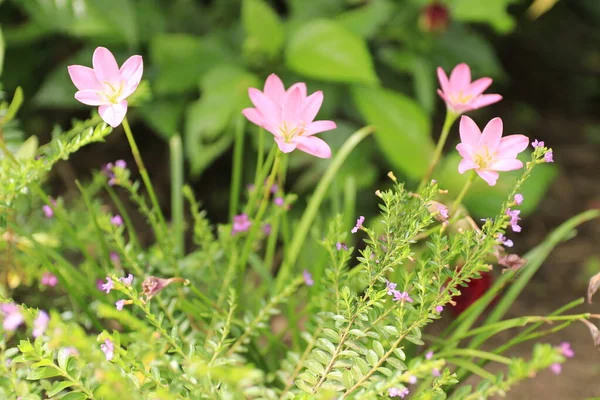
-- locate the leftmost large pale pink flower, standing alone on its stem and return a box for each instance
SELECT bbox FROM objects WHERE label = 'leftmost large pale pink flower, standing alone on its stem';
[68,47,144,128]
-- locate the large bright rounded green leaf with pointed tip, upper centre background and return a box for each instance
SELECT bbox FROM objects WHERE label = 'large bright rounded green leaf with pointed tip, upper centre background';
[285,20,378,84]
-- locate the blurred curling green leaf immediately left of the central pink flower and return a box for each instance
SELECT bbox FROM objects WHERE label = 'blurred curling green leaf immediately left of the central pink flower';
[184,65,258,174]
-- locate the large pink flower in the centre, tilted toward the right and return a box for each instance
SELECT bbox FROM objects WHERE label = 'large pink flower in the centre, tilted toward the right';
[242,74,336,158]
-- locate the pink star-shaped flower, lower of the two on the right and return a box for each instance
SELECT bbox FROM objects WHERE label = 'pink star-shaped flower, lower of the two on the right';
[456,116,529,186]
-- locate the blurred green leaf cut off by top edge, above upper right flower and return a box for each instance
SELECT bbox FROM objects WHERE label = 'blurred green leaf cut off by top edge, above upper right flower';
[450,0,516,33]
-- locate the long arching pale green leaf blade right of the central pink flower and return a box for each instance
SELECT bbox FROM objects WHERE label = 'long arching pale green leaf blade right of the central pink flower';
[275,126,374,292]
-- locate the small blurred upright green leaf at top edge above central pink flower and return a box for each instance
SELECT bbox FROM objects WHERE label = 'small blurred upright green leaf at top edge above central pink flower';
[242,0,285,58]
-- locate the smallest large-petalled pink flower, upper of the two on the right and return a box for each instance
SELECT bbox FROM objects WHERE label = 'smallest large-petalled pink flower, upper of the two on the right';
[438,63,502,114]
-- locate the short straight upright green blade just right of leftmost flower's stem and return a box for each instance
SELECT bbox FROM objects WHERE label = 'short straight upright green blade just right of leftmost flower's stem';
[169,134,185,260]
